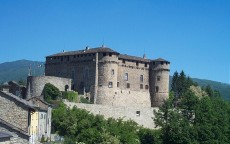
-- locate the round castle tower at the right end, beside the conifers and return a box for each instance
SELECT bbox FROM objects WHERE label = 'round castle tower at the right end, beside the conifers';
[149,58,170,107]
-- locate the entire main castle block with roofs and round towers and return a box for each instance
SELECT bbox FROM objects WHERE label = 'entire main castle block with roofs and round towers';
[45,46,170,107]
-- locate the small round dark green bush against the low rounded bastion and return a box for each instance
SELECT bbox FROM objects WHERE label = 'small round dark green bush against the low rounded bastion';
[43,83,61,102]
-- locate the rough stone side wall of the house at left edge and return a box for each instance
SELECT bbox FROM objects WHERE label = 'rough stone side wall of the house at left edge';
[0,93,29,132]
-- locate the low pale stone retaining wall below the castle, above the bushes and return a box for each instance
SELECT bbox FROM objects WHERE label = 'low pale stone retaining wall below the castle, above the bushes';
[65,102,158,129]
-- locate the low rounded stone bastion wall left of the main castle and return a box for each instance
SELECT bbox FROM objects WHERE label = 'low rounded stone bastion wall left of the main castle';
[26,76,71,99]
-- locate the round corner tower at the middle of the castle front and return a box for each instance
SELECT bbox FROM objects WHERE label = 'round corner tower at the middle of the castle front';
[95,52,119,105]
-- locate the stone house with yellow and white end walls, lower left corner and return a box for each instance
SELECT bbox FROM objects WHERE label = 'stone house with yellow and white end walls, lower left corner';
[0,91,51,144]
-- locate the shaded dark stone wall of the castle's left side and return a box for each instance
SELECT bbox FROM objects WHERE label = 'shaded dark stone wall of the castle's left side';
[45,54,96,94]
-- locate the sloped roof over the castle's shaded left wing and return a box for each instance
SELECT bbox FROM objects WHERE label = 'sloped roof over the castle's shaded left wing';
[47,47,119,57]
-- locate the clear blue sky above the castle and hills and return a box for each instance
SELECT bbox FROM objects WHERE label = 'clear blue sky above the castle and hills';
[0,0,230,83]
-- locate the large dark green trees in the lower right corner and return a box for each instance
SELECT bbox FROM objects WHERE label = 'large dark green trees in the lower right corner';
[154,90,230,144]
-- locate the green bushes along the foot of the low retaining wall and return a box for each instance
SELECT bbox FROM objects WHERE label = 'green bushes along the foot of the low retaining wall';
[52,104,155,144]
